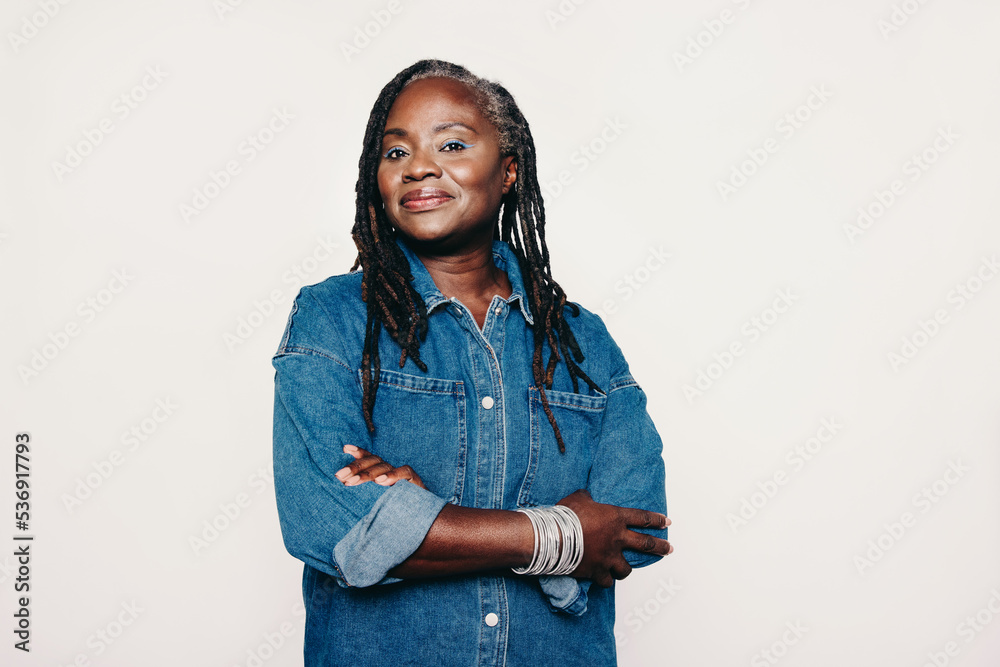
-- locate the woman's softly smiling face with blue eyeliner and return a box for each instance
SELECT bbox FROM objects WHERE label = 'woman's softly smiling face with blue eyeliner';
[378,78,517,253]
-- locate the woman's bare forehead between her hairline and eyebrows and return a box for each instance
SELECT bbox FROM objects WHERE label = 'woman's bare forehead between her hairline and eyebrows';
[386,77,491,131]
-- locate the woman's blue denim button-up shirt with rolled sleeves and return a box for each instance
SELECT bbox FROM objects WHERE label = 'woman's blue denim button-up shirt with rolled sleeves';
[272,240,667,667]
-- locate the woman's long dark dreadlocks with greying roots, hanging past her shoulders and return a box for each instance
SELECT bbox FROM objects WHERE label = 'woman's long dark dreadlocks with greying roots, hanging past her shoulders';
[351,60,601,452]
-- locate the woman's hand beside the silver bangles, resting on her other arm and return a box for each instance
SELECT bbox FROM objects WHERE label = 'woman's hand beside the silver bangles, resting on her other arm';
[557,489,674,588]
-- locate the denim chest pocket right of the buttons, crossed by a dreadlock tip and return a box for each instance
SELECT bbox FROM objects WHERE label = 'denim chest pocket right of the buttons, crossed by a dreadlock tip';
[517,387,608,507]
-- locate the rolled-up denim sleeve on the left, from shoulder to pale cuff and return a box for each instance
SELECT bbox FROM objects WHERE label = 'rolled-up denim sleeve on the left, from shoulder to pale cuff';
[272,290,445,587]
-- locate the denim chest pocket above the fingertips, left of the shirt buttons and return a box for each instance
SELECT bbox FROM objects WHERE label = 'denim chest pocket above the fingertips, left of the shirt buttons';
[358,370,467,503]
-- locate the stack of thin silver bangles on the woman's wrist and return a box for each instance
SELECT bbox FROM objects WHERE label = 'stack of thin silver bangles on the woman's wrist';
[511,505,583,575]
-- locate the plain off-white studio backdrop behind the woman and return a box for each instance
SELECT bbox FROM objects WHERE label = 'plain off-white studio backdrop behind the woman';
[0,0,1000,667]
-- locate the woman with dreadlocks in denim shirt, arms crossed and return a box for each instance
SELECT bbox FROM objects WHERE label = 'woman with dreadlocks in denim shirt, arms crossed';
[273,61,671,665]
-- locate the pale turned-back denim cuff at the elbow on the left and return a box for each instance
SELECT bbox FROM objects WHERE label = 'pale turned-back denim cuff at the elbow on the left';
[333,481,446,587]
